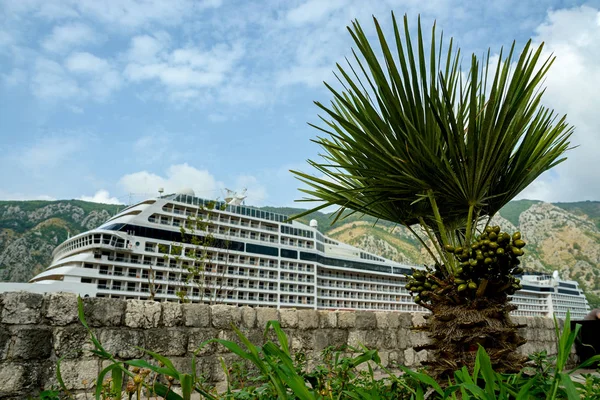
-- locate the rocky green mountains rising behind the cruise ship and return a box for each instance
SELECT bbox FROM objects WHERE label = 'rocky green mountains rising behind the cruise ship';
[0,200,600,306]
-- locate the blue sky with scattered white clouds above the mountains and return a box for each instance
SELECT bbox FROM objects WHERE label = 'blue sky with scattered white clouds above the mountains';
[0,0,600,206]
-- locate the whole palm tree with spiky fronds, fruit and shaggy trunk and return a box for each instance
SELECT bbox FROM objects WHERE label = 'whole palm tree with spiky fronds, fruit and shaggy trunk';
[292,14,573,378]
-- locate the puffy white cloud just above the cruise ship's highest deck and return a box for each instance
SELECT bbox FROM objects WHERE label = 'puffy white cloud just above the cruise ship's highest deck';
[119,163,220,198]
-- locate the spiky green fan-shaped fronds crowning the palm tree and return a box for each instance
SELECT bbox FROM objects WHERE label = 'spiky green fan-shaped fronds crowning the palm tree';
[292,14,573,270]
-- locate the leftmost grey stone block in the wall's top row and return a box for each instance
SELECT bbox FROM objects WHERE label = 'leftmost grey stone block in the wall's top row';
[0,292,44,324]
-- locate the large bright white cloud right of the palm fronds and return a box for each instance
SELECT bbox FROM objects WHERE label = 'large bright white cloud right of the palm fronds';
[520,6,600,201]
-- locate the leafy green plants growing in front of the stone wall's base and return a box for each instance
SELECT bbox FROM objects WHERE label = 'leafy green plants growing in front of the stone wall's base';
[49,299,600,400]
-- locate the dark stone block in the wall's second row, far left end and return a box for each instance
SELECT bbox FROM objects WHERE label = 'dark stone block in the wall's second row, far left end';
[8,327,52,360]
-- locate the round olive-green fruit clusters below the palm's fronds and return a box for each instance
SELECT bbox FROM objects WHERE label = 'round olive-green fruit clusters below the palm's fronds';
[406,226,525,303]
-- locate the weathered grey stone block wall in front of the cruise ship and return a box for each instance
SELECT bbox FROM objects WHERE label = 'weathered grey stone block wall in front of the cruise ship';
[0,292,568,399]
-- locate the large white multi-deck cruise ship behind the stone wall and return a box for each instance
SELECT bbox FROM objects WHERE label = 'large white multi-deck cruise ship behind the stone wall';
[0,189,589,319]
